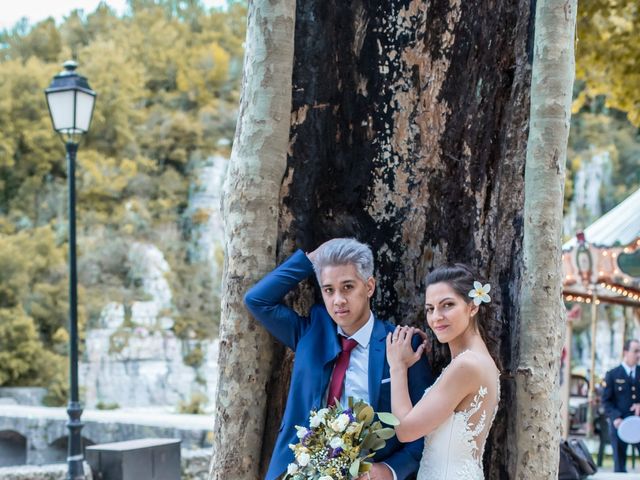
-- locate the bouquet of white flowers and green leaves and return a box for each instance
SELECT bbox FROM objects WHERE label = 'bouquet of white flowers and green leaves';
[284,398,399,480]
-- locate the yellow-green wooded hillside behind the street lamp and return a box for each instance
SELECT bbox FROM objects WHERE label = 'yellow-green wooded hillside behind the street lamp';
[0,0,246,394]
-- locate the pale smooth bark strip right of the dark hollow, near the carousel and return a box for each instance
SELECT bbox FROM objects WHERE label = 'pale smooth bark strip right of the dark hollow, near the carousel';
[515,0,577,479]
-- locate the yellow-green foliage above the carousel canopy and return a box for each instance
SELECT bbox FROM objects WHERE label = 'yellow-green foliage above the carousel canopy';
[564,0,640,228]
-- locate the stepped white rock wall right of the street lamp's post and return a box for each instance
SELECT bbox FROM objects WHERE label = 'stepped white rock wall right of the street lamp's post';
[80,242,218,409]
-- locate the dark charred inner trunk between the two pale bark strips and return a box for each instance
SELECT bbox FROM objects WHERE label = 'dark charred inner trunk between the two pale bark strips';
[265,0,533,478]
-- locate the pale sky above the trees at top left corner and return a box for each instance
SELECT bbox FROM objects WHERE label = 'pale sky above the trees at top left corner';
[0,0,226,30]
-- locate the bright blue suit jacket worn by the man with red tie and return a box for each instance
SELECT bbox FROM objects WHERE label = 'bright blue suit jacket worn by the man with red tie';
[245,251,433,480]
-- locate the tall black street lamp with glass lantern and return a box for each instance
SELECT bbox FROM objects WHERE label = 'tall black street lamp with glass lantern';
[44,60,96,480]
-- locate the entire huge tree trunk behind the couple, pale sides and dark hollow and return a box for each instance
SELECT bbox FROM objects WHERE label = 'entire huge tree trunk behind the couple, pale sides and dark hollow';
[212,0,575,479]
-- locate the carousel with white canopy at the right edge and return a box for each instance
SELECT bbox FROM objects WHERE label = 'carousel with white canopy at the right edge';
[562,190,640,435]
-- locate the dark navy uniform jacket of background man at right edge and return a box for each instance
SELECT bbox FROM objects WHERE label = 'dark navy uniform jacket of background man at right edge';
[602,365,640,421]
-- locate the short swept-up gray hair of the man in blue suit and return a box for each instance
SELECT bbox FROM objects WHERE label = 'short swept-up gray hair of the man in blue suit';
[313,238,373,283]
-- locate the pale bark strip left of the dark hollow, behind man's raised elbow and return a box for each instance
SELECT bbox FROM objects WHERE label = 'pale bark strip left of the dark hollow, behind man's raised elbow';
[209,0,295,480]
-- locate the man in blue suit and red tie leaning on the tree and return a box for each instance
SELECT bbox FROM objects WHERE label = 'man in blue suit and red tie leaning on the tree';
[245,238,433,480]
